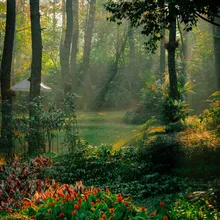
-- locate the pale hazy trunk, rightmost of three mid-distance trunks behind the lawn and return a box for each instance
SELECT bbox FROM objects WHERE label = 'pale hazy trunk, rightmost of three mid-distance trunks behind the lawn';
[82,0,96,109]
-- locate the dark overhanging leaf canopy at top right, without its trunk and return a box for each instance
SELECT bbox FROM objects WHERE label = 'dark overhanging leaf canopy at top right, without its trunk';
[105,0,220,51]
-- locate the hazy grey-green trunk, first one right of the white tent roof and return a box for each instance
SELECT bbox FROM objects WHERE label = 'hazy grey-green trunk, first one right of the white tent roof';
[61,0,73,95]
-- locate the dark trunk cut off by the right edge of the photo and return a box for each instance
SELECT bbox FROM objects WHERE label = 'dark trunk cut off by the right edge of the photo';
[213,14,220,90]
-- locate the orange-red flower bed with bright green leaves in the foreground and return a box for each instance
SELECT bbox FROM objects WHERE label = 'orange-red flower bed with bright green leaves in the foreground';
[23,181,151,220]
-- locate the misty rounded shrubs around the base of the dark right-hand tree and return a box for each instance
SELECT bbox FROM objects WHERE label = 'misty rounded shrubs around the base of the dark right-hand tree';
[124,82,193,124]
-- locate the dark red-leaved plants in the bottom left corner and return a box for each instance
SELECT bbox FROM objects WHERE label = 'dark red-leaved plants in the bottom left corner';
[0,157,51,213]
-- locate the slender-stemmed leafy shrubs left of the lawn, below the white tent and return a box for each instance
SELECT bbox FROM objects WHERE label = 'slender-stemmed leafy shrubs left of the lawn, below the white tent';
[13,94,80,153]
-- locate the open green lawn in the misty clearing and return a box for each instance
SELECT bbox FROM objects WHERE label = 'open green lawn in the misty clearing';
[76,111,139,146]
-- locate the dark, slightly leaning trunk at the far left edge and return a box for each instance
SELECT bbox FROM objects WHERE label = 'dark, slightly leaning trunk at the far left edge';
[0,0,16,155]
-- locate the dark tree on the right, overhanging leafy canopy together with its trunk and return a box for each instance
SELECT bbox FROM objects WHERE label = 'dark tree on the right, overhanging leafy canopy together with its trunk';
[105,0,220,119]
